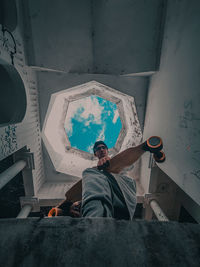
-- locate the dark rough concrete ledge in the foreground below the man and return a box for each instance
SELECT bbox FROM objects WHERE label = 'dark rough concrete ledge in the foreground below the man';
[0,217,200,267]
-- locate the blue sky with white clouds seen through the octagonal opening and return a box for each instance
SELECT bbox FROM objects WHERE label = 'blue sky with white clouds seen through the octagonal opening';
[64,95,122,153]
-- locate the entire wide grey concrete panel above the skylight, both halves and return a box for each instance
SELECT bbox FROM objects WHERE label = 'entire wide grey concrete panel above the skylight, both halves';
[23,0,166,74]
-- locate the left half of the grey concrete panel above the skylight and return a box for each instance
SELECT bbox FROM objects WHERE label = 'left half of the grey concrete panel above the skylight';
[23,0,93,72]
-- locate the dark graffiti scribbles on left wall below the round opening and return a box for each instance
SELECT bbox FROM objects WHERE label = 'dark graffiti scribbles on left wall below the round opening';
[0,125,17,156]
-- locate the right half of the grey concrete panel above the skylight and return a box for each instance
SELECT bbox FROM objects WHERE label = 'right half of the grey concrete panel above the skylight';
[93,0,166,74]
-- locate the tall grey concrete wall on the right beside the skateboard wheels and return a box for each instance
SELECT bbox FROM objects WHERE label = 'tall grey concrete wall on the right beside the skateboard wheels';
[143,0,200,204]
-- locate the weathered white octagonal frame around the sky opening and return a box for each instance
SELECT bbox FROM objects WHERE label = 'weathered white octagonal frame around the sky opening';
[42,81,142,177]
